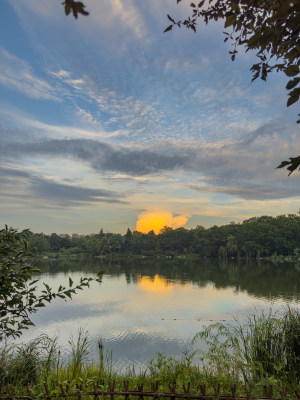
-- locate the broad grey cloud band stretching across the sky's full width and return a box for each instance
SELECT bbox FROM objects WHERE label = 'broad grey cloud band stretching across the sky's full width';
[0,115,300,200]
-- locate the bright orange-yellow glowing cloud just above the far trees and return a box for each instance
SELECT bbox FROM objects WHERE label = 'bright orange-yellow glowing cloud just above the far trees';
[136,212,188,234]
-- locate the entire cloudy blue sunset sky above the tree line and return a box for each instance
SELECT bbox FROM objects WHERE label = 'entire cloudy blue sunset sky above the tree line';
[0,0,300,234]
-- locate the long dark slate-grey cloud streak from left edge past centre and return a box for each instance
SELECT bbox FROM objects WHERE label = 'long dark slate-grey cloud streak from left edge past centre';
[0,139,187,176]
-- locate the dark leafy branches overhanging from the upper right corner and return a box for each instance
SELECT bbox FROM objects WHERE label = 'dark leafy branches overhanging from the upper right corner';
[164,0,300,175]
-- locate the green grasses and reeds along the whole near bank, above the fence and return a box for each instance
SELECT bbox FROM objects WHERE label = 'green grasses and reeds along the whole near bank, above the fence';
[0,307,300,397]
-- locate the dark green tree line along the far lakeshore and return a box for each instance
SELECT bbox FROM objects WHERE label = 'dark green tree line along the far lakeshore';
[28,214,300,259]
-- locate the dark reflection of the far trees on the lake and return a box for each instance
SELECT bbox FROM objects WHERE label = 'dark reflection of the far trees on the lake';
[39,257,300,300]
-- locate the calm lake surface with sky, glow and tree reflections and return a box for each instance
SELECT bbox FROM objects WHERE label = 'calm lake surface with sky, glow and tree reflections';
[17,259,300,369]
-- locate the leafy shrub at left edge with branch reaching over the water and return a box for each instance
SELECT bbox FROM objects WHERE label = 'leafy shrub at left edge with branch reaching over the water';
[0,226,101,341]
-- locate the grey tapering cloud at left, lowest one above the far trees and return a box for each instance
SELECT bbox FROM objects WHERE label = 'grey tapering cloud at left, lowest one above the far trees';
[0,167,127,208]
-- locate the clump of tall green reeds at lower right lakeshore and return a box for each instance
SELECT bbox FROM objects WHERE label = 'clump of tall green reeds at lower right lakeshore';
[194,307,300,385]
